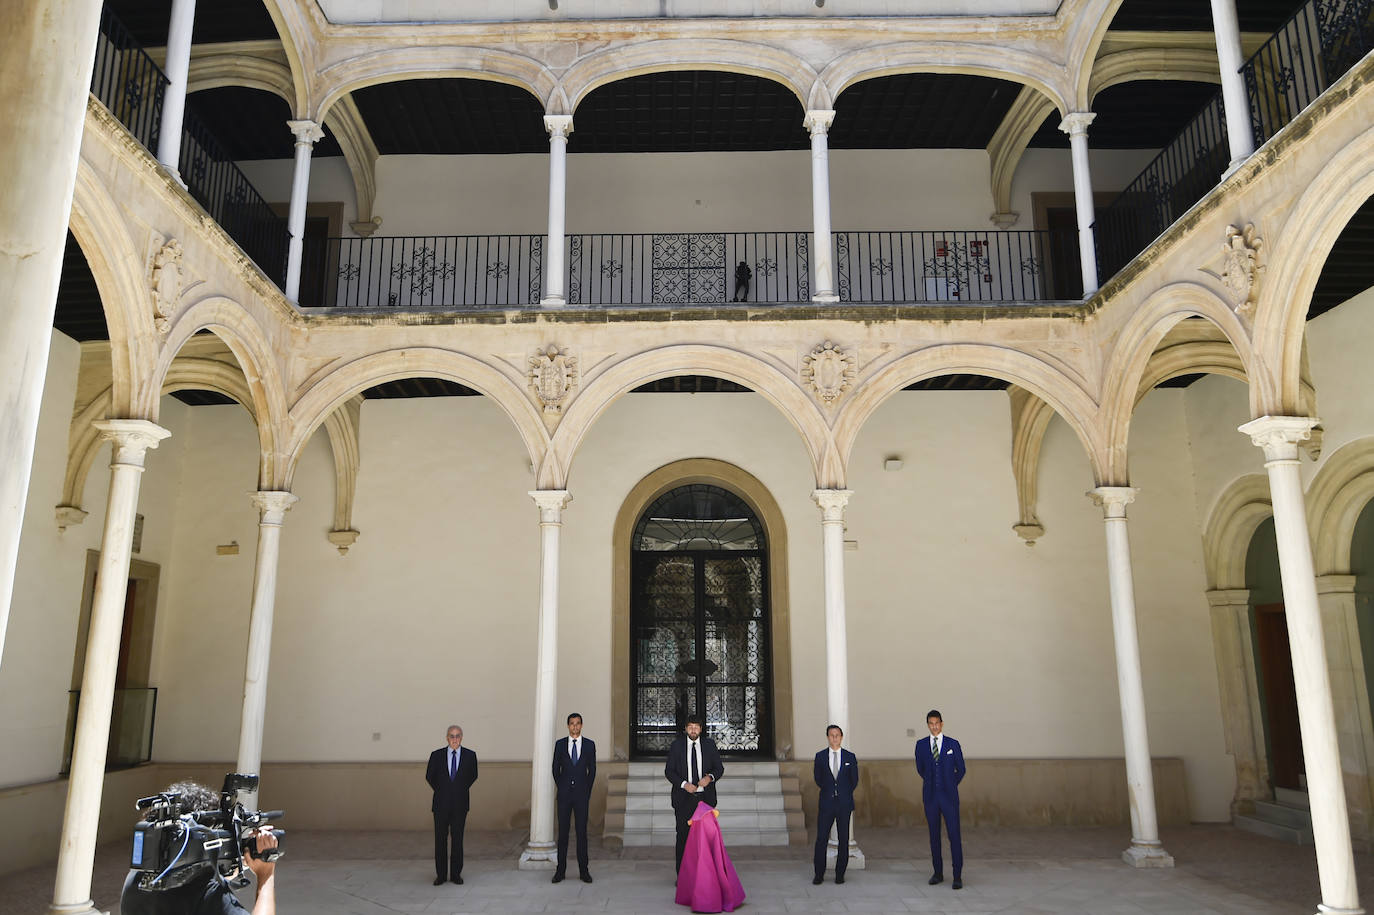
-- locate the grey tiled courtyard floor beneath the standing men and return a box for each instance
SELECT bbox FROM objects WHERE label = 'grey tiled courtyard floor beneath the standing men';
[0,826,1374,915]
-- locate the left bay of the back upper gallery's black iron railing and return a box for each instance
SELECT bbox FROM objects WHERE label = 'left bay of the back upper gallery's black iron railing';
[301,235,544,308]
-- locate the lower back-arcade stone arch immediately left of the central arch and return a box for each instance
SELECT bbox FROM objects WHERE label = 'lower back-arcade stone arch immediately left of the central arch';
[282,348,546,489]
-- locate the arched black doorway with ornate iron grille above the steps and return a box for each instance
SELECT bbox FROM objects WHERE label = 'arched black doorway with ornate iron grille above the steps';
[629,482,774,758]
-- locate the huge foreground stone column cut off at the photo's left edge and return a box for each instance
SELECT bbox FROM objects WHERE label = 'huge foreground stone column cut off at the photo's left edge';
[0,0,100,670]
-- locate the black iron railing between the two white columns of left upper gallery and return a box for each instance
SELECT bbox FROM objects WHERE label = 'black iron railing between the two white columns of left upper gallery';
[177,102,287,283]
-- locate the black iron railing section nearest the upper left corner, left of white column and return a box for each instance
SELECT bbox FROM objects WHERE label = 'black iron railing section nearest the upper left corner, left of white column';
[91,7,168,154]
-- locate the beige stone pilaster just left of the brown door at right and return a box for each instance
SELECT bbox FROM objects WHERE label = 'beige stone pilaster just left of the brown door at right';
[1206,588,1271,813]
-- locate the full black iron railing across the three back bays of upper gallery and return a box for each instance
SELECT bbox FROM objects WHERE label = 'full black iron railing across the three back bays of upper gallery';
[301,229,1079,309]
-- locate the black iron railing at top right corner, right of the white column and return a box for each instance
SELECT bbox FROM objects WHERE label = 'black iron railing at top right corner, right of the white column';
[1241,0,1374,146]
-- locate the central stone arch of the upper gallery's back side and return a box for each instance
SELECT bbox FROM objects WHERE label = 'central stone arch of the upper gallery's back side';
[559,38,818,114]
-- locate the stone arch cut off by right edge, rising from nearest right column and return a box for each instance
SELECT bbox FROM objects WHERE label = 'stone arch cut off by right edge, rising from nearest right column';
[1250,128,1374,416]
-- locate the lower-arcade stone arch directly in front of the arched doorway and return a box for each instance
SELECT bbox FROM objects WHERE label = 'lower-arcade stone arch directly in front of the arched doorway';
[539,343,844,489]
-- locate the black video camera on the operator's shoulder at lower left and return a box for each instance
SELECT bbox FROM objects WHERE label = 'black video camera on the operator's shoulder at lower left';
[131,773,284,890]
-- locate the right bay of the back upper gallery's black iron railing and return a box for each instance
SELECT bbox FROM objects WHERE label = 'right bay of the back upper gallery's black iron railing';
[835,229,1072,304]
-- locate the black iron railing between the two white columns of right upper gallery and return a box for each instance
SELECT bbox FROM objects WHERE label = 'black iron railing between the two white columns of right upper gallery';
[1094,91,1231,280]
